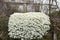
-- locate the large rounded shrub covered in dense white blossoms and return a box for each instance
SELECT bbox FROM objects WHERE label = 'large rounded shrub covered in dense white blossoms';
[8,12,50,39]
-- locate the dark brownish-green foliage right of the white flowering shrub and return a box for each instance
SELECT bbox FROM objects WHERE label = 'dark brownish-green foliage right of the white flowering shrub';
[50,11,60,40]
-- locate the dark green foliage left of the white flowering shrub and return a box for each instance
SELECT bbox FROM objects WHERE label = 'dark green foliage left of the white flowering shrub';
[0,14,8,40]
